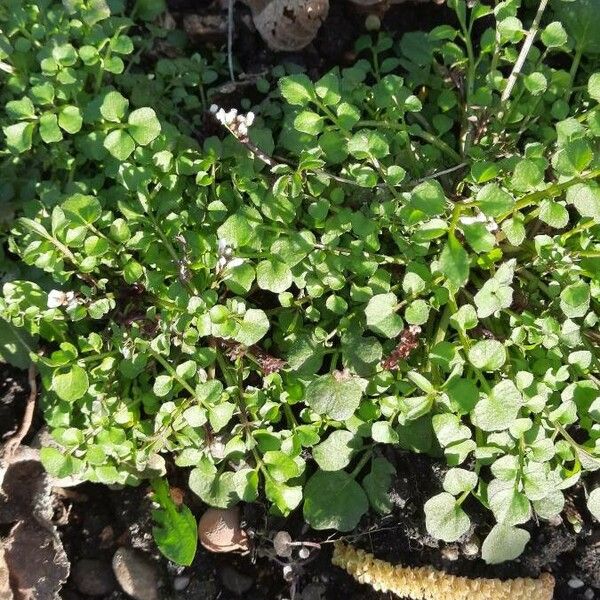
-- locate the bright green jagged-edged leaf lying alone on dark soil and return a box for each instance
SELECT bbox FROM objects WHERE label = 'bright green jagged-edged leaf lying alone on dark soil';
[152,479,198,566]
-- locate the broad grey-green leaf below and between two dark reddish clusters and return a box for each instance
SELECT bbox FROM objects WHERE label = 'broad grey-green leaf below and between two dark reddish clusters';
[305,371,366,421]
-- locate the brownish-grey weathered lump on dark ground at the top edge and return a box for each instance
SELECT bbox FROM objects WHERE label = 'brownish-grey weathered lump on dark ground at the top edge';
[245,0,329,52]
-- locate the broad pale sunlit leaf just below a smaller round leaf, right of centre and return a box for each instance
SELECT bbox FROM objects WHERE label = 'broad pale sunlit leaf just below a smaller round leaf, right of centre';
[472,379,523,431]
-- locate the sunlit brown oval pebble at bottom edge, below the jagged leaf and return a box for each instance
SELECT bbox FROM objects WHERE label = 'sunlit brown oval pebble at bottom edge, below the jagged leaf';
[112,548,158,600]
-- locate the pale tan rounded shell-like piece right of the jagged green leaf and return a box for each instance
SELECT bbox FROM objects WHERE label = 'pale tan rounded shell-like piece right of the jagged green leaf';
[198,506,250,552]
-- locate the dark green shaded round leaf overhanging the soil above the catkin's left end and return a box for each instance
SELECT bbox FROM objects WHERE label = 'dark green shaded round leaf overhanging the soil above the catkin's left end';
[303,471,369,531]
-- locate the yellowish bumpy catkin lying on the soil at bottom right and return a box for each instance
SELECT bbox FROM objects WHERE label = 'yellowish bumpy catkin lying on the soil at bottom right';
[332,542,554,600]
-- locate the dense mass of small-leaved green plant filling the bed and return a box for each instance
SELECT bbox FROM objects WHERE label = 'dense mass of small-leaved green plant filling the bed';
[0,0,600,562]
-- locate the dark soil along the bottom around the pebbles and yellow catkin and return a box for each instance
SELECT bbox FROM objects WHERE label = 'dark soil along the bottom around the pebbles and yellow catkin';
[0,365,600,600]
